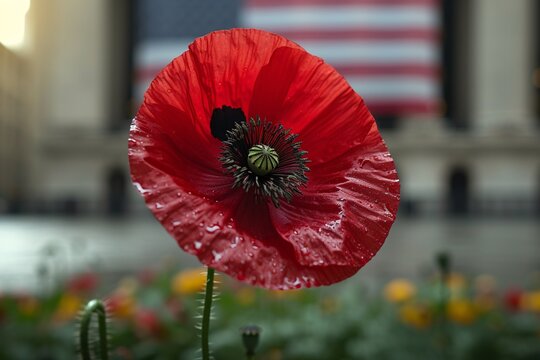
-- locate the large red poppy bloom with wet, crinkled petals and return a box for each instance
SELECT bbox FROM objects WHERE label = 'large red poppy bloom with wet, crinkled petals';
[129,29,399,289]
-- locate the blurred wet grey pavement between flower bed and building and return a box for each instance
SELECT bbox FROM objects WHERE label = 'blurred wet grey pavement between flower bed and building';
[0,215,540,292]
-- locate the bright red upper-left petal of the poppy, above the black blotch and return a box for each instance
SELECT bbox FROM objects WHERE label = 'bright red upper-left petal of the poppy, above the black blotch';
[143,29,298,145]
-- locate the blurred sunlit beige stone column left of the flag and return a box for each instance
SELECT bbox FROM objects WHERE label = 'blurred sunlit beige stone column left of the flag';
[31,0,109,131]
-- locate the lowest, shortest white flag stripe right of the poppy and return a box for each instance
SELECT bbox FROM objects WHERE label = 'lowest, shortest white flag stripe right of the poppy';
[347,76,439,100]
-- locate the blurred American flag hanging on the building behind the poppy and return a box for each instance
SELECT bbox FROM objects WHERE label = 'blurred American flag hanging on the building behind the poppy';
[135,0,441,116]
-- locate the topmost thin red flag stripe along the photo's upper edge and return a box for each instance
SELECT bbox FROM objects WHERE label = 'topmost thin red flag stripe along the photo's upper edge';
[246,0,440,7]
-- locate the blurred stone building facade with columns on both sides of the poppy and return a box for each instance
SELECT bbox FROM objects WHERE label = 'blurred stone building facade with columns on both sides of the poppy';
[0,0,540,215]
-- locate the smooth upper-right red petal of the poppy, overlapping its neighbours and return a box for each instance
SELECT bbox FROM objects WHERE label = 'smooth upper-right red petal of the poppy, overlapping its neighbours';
[249,47,374,164]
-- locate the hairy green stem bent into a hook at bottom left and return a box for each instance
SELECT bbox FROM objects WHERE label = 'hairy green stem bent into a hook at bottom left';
[79,299,109,360]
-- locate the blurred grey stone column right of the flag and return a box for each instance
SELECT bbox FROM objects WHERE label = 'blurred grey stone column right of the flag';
[465,0,534,132]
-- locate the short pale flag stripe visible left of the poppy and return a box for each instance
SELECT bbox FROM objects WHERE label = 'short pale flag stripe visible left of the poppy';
[135,39,193,68]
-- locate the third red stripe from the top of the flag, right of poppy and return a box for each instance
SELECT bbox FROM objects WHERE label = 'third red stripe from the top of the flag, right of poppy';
[334,64,440,78]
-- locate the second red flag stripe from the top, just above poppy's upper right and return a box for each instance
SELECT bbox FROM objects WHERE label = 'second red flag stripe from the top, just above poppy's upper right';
[278,28,440,42]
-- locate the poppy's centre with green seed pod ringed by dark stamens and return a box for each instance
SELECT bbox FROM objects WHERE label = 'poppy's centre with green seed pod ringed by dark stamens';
[220,118,309,207]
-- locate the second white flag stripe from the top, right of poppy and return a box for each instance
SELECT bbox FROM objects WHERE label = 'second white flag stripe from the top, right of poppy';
[300,40,439,65]
